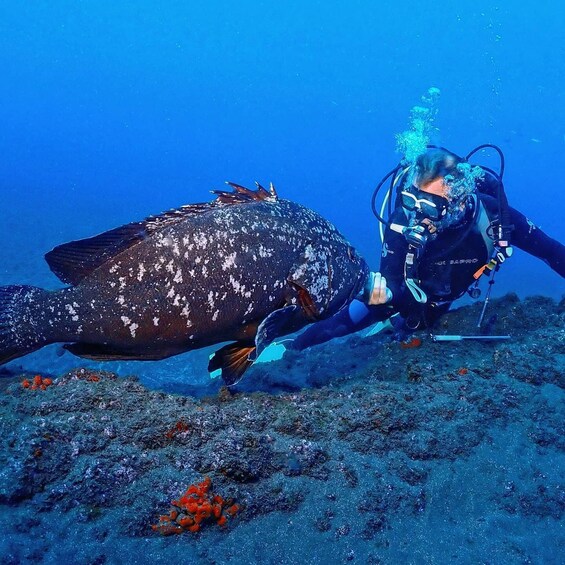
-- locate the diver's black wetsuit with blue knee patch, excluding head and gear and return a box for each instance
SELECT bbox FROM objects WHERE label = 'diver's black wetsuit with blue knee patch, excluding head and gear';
[289,194,565,350]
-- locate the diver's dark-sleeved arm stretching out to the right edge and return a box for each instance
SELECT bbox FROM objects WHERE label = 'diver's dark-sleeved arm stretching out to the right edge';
[510,208,565,278]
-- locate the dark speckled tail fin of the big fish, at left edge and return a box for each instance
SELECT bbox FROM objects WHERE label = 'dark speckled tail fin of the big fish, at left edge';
[0,285,49,365]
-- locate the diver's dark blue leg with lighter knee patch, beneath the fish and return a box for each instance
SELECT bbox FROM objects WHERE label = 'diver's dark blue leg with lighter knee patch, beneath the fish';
[285,300,394,351]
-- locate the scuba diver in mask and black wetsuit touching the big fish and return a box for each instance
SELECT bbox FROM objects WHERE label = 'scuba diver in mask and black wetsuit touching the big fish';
[264,145,565,352]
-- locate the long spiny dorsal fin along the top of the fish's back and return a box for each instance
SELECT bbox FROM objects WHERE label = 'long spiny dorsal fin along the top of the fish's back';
[45,182,278,285]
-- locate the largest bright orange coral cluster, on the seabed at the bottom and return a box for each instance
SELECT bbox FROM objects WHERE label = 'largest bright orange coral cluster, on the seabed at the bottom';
[151,477,239,536]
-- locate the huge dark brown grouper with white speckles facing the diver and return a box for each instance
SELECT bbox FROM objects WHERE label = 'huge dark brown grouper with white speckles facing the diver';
[0,183,369,385]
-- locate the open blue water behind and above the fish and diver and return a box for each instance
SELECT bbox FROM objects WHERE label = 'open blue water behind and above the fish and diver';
[0,1,565,290]
